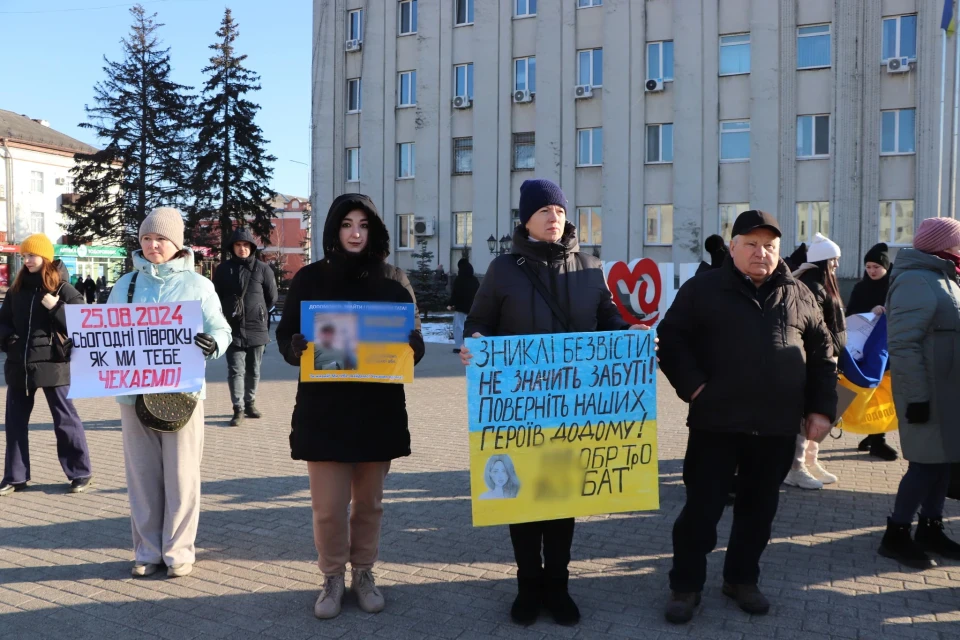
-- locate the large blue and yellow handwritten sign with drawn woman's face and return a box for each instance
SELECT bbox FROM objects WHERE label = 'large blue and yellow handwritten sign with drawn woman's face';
[466,331,660,526]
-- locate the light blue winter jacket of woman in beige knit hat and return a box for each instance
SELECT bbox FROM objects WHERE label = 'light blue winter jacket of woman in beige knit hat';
[107,249,233,404]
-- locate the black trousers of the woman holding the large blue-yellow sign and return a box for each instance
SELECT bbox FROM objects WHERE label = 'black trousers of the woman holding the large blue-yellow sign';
[510,518,574,589]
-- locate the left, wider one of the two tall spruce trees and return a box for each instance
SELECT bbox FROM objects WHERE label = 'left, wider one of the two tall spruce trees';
[63,5,194,251]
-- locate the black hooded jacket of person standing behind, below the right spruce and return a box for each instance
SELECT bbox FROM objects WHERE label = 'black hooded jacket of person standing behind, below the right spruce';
[213,228,277,348]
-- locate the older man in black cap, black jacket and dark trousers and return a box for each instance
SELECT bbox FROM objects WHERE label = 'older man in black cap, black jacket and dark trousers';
[658,211,837,623]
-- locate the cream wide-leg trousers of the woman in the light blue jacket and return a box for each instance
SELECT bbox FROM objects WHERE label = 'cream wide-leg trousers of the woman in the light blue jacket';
[120,400,203,567]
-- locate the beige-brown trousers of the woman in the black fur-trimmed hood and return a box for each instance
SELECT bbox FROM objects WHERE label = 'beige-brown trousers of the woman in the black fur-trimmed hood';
[307,462,390,576]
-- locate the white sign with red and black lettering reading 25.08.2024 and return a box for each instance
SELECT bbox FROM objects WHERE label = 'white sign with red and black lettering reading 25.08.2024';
[64,300,206,398]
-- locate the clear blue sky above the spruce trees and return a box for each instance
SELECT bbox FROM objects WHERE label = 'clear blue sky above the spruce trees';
[0,0,313,196]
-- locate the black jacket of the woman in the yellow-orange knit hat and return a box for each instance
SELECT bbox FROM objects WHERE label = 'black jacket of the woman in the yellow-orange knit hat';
[0,265,84,390]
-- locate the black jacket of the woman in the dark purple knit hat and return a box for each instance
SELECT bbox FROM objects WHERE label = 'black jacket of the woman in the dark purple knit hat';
[463,223,630,336]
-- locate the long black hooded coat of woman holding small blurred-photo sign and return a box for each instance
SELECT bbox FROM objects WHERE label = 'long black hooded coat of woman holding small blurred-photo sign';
[277,194,424,462]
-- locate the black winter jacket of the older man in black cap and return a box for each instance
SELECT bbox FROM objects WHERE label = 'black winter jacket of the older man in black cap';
[657,260,837,435]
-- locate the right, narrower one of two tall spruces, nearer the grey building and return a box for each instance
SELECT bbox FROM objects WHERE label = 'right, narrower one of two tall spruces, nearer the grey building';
[188,8,276,257]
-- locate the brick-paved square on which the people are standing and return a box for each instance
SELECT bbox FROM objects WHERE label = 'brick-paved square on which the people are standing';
[0,343,960,640]
